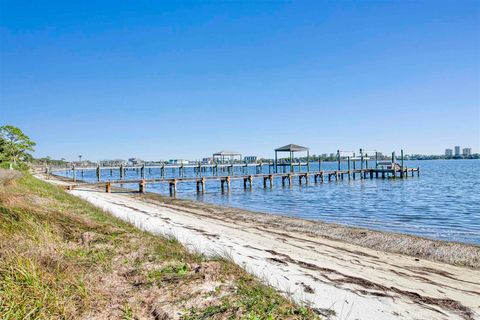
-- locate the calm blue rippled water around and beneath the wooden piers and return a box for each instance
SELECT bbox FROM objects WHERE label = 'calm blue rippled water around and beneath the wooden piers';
[62,160,480,244]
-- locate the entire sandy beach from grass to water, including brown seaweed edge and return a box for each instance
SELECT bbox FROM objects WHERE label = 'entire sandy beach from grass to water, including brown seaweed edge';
[39,175,480,319]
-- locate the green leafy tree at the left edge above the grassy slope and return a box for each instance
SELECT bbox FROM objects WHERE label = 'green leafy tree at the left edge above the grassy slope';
[0,125,35,164]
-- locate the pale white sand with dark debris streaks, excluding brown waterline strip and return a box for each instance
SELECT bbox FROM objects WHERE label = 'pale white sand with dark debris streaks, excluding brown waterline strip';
[64,189,480,319]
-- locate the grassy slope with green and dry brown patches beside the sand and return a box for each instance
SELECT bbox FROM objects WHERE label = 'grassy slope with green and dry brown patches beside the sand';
[0,175,317,319]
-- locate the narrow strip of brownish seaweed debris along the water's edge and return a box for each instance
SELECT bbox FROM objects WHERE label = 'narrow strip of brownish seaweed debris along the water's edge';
[43,174,480,269]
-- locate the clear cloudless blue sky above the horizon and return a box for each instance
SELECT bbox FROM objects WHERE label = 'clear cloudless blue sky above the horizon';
[0,0,480,160]
